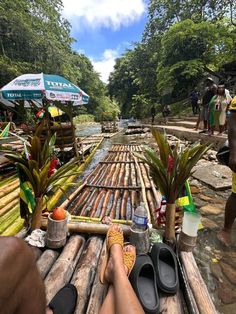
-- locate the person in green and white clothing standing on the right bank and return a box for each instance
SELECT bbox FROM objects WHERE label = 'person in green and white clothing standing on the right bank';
[209,84,232,134]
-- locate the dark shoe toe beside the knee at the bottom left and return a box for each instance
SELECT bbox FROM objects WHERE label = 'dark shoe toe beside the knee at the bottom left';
[48,284,77,314]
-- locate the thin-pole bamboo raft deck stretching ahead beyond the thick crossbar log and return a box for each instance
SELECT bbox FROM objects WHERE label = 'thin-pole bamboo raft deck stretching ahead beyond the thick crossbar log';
[67,144,161,221]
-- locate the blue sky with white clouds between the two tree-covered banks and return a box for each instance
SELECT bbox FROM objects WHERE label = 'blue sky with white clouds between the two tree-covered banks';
[63,0,147,83]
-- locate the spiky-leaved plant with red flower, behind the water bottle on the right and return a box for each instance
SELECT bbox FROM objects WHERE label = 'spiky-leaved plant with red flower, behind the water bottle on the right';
[136,128,209,239]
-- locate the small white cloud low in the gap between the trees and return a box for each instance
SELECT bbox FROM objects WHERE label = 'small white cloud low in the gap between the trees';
[90,49,119,83]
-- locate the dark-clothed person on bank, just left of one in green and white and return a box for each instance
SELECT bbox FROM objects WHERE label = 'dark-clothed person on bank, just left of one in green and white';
[199,77,217,133]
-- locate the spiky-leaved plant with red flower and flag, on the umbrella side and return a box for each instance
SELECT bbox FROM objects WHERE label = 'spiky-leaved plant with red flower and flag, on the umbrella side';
[6,127,80,229]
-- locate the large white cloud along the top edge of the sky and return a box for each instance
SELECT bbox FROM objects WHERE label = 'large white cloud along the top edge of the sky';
[63,0,145,29]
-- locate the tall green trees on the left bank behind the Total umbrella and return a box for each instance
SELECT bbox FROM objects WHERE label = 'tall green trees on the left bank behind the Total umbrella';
[0,0,118,121]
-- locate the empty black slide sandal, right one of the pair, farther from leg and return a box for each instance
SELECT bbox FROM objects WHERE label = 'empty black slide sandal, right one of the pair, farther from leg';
[151,243,179,294]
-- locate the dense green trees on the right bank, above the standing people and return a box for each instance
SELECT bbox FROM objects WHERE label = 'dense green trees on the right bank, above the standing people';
[108,0,236,118]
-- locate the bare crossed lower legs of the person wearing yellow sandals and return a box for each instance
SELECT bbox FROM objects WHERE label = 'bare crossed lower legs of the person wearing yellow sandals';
[99,227,144,314]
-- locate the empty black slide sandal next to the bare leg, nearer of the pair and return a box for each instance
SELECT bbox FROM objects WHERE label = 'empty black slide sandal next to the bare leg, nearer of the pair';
[130,254,160,314]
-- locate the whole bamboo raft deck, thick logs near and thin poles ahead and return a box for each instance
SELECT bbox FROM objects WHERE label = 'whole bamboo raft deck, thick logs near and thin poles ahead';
[16,145,216,314]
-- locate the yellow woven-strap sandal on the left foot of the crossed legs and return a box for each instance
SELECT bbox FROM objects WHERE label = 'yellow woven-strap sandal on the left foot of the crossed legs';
[100,224,124,284]
